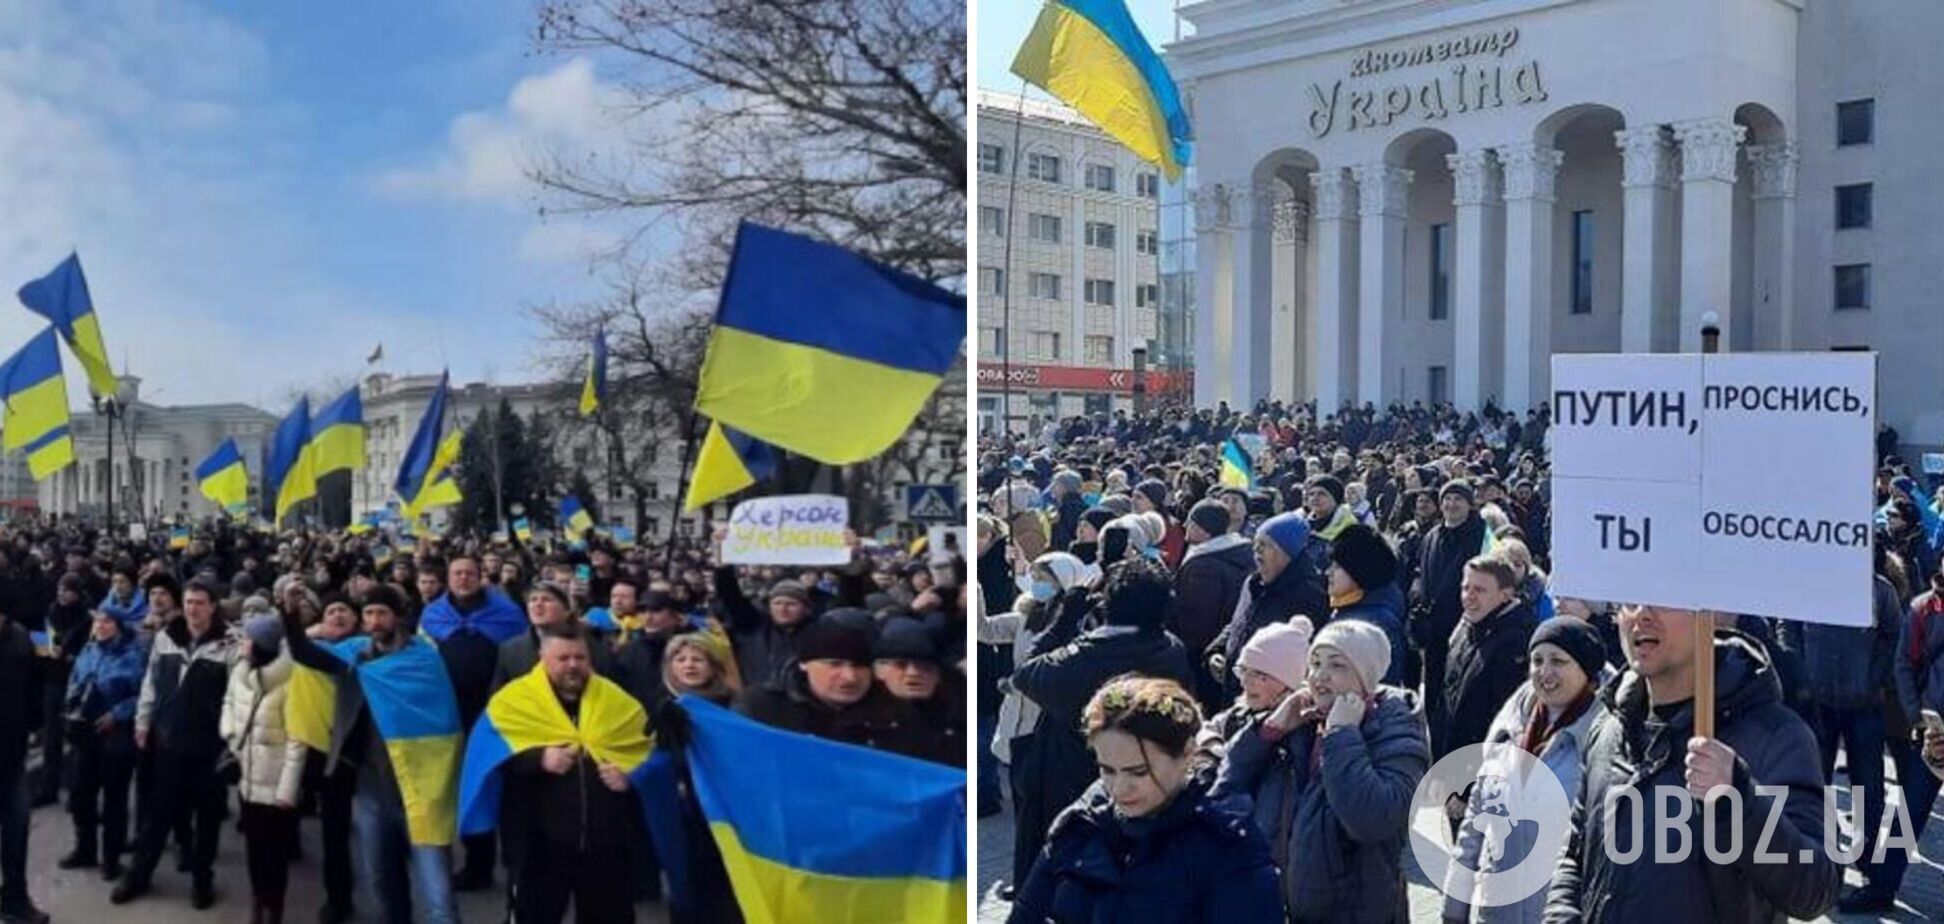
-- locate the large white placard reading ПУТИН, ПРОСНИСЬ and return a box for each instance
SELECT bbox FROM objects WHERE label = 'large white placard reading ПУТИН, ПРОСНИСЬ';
[1549,354,1876,626]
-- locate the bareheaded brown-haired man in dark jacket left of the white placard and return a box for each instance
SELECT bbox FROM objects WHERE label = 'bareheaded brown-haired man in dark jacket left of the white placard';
[1433,554,1538,759]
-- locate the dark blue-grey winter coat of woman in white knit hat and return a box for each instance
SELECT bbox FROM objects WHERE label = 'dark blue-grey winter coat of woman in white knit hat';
[1217,687,1431,922]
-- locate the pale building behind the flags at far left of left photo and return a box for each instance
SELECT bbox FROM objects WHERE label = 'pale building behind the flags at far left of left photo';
[35,375,276,521]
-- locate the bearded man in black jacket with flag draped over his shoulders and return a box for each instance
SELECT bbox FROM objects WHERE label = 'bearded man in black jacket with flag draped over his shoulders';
[500,622,642,922]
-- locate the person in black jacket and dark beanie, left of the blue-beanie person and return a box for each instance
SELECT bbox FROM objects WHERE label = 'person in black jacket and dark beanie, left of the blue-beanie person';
[1166,500,1256,710]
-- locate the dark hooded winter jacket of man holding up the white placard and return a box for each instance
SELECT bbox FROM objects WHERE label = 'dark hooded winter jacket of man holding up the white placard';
[1545,632,1843,924]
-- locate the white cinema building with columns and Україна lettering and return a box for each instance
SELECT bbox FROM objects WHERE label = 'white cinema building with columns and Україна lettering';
[1174,0,1944,444]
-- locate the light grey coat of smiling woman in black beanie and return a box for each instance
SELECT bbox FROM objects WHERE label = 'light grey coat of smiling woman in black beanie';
[1444,671,1612,924]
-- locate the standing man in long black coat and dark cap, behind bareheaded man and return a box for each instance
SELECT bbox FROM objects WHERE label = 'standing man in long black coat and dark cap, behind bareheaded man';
[1406,479,1485,759]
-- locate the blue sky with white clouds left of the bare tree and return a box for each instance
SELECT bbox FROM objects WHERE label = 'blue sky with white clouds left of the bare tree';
[0,0,620,412]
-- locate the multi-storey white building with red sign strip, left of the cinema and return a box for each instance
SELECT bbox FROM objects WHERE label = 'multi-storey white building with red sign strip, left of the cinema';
[974,91,1184,430]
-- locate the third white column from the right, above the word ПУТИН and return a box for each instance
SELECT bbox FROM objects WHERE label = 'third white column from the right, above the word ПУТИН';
[1614,124,1678,352]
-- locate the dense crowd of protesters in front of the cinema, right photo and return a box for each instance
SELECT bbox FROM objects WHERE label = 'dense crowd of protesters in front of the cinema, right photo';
[976,403,1944,922]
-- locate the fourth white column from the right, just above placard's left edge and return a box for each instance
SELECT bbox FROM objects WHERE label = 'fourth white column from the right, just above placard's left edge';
[1497,142,1565,410]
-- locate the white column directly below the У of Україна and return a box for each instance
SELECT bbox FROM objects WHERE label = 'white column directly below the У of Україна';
[1310,167,1357,420]
